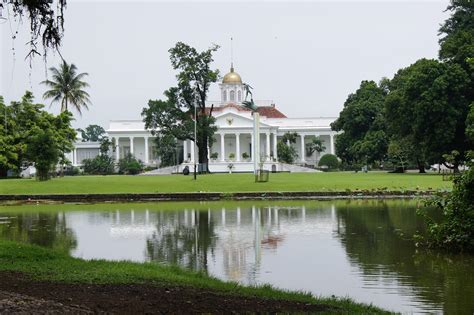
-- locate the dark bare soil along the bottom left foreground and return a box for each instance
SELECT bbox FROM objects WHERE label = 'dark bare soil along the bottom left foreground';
[0,272,336,314]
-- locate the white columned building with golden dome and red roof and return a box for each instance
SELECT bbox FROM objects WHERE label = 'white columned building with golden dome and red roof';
[71,67,336,172]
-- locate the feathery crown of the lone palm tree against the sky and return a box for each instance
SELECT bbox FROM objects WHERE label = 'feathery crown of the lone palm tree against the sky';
[41,61,90,115]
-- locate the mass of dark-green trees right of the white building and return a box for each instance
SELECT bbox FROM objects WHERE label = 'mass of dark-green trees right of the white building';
[331,0,474,172]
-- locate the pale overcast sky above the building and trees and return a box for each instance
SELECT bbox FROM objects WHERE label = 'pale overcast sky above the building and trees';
[0,0,449,129]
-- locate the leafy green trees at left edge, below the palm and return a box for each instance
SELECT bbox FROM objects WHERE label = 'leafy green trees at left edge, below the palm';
[0,92,76,180]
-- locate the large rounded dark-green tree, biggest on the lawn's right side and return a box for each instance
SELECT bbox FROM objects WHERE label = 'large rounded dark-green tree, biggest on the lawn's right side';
[385,59,469,172]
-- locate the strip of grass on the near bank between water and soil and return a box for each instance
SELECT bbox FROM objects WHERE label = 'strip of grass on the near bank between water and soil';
[0,240,387,314]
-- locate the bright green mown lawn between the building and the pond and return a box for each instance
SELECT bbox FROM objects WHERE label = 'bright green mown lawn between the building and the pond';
[0,172,452,194]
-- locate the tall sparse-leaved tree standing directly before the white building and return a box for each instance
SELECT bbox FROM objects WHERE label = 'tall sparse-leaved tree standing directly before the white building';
[142,42,219,170]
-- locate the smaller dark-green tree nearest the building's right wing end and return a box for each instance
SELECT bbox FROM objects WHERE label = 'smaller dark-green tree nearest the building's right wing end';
[331,79,388,165]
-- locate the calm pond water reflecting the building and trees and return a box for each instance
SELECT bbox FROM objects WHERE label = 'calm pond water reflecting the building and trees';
[0,200,474,314]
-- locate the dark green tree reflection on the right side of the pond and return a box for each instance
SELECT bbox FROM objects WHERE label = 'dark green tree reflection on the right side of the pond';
[337,201,474,314]
